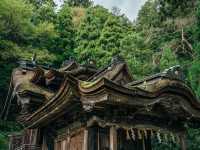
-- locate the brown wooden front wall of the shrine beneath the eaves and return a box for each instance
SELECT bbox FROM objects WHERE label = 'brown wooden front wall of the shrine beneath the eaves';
[42,126,151,150]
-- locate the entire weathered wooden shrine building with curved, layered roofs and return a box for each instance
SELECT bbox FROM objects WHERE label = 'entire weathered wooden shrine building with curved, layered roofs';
[1,57,200,150]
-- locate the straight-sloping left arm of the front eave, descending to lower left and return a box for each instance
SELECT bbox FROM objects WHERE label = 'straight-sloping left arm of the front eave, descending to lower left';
[24,76,78,128]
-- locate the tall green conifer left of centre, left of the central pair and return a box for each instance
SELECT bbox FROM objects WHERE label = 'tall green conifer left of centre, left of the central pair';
[75,6,111,62]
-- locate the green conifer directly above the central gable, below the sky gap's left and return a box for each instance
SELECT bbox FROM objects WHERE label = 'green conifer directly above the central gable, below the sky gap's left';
[98,15,129,63]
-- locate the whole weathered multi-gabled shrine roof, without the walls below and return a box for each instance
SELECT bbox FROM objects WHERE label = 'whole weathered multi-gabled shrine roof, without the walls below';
[3,56,200,131]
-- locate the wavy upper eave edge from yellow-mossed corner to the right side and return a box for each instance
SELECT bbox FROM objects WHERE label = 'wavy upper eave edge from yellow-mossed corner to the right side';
[79,77,196,104]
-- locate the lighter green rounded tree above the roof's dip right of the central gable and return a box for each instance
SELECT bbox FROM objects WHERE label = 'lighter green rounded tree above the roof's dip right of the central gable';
[120,31,153,79]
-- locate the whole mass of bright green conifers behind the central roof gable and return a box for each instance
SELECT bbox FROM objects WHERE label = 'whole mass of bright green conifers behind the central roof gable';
[75,6,152,74]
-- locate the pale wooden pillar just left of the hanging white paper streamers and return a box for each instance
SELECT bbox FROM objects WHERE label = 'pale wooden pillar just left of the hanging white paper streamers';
[110,127,117,150]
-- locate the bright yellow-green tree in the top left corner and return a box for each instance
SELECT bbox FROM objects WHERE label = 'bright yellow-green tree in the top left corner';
[0,0,32,44]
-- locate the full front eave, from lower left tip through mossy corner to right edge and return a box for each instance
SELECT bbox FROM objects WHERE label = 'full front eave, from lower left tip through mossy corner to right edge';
[26,72,200,127]
